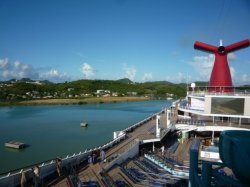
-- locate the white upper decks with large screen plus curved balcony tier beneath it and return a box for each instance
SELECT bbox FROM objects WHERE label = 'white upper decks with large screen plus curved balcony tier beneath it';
[173,87,250,129]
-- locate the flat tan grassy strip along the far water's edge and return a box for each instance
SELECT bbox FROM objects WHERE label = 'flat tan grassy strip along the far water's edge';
[0,97,151,106]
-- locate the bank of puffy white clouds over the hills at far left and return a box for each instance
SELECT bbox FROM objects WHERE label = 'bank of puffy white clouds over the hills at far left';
[0,58,68,82]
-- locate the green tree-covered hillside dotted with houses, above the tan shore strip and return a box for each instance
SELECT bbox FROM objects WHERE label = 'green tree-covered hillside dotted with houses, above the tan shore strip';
[0,79,186,102]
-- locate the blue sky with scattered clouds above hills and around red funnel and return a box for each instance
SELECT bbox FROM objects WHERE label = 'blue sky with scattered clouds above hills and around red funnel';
[0,0,250,85]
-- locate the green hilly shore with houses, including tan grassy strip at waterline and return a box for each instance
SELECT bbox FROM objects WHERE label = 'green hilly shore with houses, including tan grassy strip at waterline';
[0,78,186,106]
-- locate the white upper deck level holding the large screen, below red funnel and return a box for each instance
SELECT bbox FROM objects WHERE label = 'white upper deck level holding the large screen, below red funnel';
[178,87,250,118]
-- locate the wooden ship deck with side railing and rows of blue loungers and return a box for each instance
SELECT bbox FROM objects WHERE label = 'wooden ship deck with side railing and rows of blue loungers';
[0,109,191,186]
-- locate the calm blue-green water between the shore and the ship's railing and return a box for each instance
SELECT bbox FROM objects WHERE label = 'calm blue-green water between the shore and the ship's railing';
[0,100,170,173]
